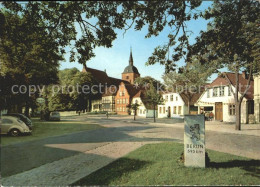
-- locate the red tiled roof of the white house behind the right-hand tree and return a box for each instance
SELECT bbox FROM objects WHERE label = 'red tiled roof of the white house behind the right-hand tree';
[209,72,254,100]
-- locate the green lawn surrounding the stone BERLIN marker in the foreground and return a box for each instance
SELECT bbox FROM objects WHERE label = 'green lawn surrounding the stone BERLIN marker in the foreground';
[73,143,260,186]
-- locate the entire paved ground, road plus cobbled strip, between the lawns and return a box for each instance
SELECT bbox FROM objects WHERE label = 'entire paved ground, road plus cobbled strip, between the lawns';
[1,115,260,186]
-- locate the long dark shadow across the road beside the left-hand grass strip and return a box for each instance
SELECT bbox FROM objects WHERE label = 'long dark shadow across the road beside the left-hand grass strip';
[0,126,179,177]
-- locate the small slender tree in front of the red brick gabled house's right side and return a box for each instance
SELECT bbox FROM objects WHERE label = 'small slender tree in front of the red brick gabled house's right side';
[144,84,164,122]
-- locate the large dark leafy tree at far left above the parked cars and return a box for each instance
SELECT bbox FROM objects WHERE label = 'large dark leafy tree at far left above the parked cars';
[0,9,62,116]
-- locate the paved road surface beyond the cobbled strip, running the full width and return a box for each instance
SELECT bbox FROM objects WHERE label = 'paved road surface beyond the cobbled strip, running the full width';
[1,116,260,185]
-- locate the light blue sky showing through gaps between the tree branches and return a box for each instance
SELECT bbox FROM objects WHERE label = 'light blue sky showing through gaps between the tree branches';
[60,1,217,82]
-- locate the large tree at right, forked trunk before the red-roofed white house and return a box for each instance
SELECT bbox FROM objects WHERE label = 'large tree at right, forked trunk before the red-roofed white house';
[190,0,260,130]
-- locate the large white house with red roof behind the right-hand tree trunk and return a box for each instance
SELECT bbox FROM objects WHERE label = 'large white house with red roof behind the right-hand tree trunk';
[195,72,254,123]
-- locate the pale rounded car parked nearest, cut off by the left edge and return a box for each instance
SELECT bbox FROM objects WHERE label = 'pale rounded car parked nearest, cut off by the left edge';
[0,116,32,136]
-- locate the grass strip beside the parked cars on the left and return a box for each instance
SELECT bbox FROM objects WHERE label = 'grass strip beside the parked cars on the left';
[1,119,102,145]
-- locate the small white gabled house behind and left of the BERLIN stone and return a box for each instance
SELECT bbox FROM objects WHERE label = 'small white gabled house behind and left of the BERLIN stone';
[158,92,200,118]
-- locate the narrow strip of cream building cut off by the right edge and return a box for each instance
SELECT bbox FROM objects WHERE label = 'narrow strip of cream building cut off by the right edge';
[254,72,260,123]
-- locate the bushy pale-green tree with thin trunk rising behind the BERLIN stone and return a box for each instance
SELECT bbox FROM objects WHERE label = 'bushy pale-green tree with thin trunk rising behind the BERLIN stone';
[163,56,215,114]
